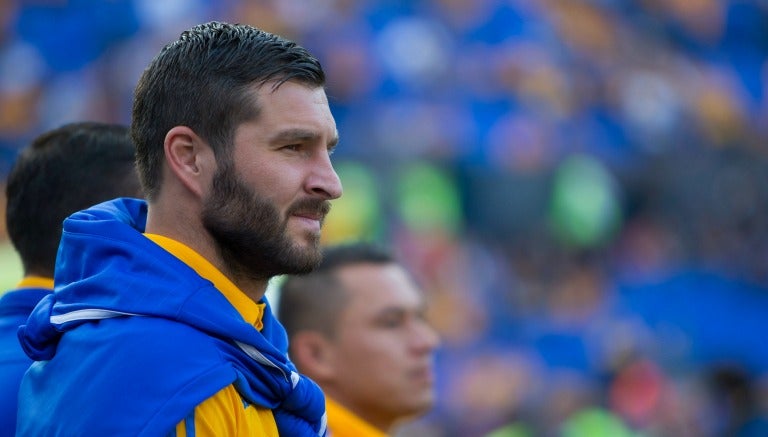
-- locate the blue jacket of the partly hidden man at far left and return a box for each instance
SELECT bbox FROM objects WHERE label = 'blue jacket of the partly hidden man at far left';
[0,288,52,437]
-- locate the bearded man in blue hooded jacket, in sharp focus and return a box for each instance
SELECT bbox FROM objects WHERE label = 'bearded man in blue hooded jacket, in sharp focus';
[17,22,342,436]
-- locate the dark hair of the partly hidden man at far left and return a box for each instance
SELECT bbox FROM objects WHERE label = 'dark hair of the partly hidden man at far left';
[5,122,141,277]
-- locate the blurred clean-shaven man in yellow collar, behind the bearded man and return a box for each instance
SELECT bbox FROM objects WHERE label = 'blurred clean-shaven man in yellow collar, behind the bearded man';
[278,243,439,437]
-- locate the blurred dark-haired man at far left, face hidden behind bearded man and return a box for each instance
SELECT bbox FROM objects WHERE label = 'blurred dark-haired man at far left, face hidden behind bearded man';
[0,122,141,435]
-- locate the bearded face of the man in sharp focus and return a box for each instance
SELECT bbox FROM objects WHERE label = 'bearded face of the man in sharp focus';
[202,82,342,279]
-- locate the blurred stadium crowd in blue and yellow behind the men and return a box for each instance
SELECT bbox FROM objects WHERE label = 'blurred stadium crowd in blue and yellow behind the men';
[0,0,768,437]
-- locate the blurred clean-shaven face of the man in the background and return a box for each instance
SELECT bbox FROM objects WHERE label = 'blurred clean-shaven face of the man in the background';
[330,263,438,423]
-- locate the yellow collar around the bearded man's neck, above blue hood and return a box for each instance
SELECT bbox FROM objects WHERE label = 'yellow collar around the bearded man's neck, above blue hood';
[144,234,266,330]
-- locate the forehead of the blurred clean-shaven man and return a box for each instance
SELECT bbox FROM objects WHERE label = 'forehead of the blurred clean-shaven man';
[337,263,424,314]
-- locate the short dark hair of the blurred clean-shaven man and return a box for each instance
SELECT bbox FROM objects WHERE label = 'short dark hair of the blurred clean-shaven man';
[277,242,396,338]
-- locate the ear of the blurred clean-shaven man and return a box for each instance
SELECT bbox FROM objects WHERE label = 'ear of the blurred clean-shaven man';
[290,331,336,383]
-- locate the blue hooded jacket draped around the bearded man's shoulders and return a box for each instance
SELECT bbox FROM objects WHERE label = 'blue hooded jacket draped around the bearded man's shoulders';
[17,199,325,436]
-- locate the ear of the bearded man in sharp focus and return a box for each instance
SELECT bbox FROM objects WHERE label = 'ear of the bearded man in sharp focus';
[163,126,216,197]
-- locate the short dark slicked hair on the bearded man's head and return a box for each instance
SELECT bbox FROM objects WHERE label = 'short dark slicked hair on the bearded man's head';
[131,21,325,200]
